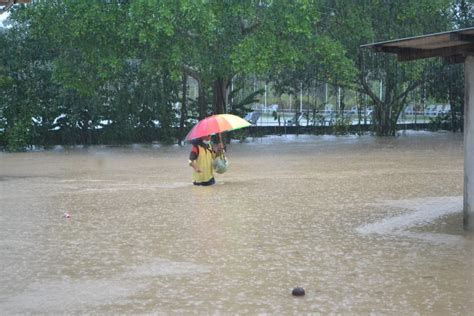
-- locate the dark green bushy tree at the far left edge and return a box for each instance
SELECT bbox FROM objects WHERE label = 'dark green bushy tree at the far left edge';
[0,14,57,150]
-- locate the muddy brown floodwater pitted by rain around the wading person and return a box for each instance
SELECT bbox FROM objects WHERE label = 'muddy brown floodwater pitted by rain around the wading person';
[0,132,474,315]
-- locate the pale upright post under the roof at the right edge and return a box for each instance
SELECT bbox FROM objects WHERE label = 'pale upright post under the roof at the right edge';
[463,56,474,231]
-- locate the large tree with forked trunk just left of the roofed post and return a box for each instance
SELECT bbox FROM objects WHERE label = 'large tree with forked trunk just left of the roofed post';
[323,0,451,135]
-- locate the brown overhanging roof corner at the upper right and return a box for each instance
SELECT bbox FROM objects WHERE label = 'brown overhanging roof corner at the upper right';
[360,27,474,63]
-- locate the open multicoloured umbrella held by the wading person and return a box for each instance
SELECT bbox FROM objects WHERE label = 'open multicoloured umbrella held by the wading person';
[185,114,251,141]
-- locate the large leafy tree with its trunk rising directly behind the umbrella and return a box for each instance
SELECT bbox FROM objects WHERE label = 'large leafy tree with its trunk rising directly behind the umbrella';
[131,0,354,117]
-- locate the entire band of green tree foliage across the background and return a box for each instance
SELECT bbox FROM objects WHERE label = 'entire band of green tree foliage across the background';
[0,0,464,150]
